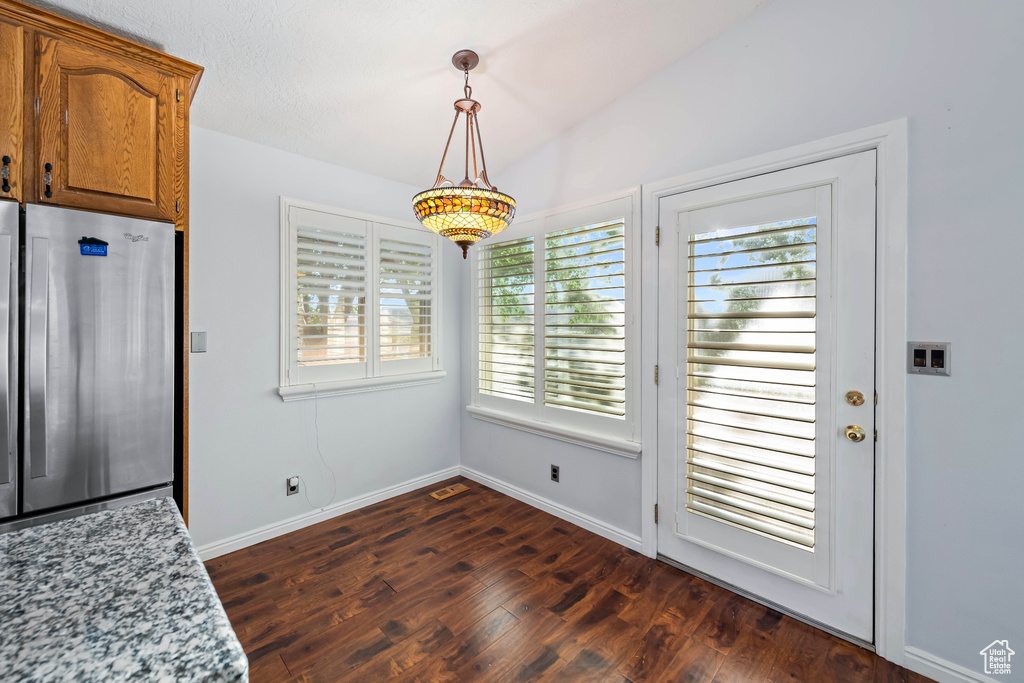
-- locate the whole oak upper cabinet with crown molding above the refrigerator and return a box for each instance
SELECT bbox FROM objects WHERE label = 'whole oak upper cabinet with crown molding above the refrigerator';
[0,0,203,232]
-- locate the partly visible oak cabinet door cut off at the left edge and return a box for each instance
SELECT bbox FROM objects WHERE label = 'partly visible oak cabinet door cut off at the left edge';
[0,20,25,201]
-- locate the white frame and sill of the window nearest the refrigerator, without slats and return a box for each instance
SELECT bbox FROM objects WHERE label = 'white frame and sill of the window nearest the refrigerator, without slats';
[278,197,446,401]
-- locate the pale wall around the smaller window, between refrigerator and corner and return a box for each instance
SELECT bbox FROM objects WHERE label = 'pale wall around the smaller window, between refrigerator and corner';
[188,127,463,547]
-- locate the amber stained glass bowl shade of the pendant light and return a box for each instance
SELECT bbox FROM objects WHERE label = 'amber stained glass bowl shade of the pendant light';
[413,186,515,258]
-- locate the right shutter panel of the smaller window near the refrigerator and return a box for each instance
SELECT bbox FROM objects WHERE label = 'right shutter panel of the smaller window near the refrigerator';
[378,225,435,374]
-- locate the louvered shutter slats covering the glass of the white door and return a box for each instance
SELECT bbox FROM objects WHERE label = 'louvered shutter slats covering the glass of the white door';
[686,218,816,550]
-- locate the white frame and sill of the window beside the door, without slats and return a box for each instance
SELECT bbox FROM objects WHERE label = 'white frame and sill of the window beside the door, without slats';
[466,187,641,458]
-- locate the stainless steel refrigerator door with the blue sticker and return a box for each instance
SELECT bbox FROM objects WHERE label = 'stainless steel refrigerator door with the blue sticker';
[22,205,174,512]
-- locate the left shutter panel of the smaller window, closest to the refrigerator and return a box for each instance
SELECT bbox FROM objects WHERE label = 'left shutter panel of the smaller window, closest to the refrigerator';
[293,209,369,382]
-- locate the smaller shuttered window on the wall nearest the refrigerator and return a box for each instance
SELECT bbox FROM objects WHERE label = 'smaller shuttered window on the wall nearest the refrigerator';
[279,199,444,400]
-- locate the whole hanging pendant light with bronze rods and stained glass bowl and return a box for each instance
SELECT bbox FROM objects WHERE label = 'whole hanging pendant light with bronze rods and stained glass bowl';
[413,50,515,258]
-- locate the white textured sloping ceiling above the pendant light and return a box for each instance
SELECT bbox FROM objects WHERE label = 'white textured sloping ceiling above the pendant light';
[31,0,767,190]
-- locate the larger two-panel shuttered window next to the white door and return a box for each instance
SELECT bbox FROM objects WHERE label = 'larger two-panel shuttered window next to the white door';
[469,196,639,456]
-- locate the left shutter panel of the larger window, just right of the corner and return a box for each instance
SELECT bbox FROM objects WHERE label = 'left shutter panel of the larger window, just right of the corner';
[477,238,536,402]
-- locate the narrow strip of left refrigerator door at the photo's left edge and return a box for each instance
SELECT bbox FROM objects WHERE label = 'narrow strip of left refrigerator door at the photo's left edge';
[0,202,18,519]
